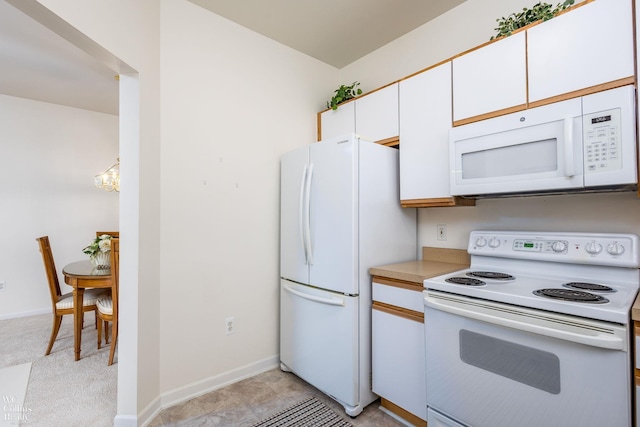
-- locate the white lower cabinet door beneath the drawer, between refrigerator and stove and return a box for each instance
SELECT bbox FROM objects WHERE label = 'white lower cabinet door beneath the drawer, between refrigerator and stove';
[372,309,427,420]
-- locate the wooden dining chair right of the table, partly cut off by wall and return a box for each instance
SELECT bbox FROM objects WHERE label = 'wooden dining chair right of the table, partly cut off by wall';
[96,238,120,365]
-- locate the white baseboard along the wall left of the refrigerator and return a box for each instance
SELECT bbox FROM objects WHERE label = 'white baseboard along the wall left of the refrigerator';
[138,355,280,427]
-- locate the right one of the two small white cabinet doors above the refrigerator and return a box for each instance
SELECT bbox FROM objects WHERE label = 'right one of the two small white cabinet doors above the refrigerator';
[355,83,398,142]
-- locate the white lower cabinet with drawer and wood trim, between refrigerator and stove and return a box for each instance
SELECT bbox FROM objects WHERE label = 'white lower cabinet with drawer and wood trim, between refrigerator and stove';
[372,277,427,426]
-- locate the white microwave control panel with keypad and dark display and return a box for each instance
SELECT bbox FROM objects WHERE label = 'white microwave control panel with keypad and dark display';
[582,108,622,174]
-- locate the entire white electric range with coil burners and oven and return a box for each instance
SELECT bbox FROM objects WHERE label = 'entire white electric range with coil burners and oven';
[424,231,640,427]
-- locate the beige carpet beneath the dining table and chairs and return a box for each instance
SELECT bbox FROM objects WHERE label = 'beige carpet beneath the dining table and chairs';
[0,313,118,427]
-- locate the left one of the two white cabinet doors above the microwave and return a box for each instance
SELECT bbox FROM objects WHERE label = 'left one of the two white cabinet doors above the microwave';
[453,32,527,122]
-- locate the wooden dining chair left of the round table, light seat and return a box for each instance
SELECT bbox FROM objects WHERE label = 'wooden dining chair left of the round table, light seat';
[36,236,105,356]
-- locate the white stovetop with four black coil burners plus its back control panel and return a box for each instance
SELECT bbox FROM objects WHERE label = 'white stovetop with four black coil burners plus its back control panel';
[424,231,640,324]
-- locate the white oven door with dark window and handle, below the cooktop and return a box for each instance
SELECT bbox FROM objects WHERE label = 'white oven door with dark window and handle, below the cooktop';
[424,290,631,427]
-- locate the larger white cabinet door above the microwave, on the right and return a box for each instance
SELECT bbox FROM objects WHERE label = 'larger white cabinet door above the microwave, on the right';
[527,0,634,102]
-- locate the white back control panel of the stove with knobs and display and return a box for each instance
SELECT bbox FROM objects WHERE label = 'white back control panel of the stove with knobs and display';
[468,231,640,268]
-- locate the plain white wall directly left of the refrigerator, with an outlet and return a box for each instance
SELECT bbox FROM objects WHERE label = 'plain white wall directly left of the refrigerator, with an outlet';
[160,0,337,402]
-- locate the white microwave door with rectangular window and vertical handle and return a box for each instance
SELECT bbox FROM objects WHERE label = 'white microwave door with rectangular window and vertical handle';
[449,98,584,196]
